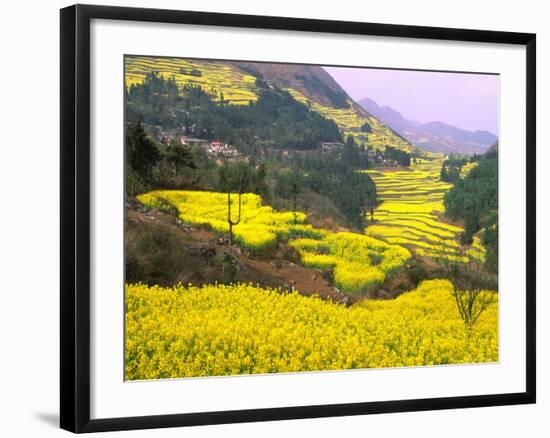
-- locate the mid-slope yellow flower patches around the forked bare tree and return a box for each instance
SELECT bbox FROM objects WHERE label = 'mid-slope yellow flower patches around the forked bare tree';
[137,190,411,293]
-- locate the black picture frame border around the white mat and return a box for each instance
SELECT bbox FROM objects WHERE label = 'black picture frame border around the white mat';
[60,5,536,433]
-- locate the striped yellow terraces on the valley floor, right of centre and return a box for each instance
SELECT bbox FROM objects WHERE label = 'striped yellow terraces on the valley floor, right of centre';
[366,155,482,256]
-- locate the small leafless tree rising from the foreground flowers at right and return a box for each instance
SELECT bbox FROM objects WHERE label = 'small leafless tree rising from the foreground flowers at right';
[437,249,498,329]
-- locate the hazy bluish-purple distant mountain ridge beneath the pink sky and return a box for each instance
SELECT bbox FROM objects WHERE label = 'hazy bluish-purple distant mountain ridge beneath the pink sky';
[359,98,498,154]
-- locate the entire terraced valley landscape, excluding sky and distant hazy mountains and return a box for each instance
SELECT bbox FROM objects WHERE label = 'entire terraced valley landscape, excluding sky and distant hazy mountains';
[125,56,499,380]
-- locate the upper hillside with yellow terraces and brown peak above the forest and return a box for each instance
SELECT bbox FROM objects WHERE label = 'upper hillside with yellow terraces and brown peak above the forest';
[125,56,423,153]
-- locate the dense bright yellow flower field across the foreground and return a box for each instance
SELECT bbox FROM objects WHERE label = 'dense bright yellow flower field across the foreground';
[126,280,498,380]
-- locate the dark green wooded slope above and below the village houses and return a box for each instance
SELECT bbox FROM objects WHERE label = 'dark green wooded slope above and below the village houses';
[125,73,376,229]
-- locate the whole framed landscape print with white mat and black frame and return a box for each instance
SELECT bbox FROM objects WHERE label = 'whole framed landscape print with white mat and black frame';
[61,5,536,432]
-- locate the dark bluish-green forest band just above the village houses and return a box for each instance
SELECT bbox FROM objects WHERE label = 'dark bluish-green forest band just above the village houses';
[126,73,341,150]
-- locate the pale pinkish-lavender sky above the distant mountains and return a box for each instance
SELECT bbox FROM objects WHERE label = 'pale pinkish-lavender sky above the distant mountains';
[325,67,499,135]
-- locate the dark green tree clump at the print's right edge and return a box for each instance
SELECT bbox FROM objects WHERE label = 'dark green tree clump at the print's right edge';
[444,152,498,272]
